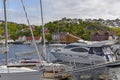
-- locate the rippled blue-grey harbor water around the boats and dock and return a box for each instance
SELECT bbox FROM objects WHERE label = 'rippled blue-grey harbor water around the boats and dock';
[0,44,120,80]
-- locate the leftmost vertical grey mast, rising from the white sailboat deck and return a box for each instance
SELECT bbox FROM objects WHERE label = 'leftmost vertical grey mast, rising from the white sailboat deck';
[3,0,8,65]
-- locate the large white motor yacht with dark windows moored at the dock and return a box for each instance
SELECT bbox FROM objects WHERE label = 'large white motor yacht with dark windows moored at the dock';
[51,40,116,64]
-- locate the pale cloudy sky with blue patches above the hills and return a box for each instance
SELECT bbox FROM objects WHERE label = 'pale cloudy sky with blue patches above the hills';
[0,0,120,25]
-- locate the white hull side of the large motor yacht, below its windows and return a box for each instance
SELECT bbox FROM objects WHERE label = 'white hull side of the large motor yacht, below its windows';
[52,52,105,64]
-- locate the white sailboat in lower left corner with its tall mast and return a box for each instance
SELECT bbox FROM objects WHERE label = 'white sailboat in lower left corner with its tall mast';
[0,0,44,80]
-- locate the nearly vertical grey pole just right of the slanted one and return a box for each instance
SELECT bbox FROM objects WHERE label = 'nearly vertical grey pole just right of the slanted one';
[40,0,46,60]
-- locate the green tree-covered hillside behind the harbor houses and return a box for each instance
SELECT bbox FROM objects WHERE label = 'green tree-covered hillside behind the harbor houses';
[0,19,120,41]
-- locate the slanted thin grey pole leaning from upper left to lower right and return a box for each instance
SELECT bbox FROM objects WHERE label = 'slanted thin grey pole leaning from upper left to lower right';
[21,0,41,61]
